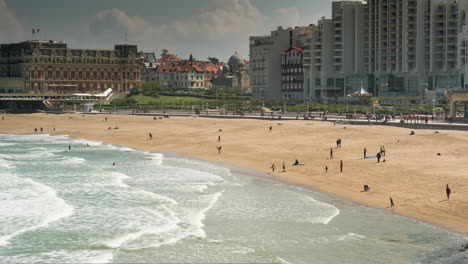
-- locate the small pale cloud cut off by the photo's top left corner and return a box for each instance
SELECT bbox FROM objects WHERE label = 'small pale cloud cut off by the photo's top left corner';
[0,0,25,42]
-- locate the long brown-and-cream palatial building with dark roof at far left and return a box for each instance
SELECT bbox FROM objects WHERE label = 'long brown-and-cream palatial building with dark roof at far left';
[0,40,140,94]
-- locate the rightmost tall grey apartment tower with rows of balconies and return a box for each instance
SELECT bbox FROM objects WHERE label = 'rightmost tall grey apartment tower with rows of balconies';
[365,0,466,96]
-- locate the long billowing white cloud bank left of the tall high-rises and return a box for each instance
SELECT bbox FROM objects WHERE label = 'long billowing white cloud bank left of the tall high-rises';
[90,0,265,43]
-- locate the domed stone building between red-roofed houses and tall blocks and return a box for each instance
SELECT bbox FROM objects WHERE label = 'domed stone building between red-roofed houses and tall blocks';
[212,52,252,93]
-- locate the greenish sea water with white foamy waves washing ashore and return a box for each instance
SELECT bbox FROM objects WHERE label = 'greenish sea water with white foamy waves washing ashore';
[0,135,468,263]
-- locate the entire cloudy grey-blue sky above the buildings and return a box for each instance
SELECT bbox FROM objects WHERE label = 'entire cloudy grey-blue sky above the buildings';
[0,0,356,61]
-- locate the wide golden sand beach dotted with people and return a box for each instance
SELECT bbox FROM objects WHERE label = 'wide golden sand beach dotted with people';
[0,114,468,234]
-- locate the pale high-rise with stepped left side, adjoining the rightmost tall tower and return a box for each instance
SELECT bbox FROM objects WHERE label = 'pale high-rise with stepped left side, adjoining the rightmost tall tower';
[304,1,368,101]
